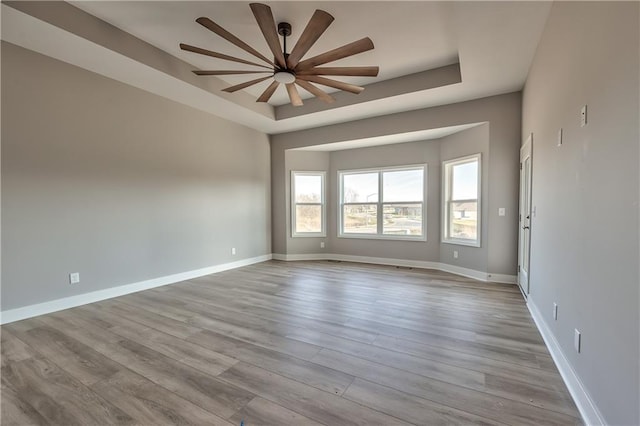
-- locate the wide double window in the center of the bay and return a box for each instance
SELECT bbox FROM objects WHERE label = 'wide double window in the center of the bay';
[339,166,425,241]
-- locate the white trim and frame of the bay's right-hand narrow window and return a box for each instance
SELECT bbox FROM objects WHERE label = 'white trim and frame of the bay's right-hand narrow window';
[441,152,482,247]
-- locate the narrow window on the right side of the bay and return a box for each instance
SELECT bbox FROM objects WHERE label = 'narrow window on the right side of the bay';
[442,154,481,247]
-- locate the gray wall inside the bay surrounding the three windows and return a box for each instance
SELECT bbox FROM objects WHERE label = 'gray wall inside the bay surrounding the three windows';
[285,123,498,272]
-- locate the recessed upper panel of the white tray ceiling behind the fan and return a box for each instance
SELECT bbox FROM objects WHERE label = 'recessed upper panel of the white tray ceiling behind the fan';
[72,1,458,105]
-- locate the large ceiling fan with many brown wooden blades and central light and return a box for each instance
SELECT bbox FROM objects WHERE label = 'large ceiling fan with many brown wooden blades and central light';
[180,3,379,106]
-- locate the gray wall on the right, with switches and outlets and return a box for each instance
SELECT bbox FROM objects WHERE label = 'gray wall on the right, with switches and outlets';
[522,2,640,425]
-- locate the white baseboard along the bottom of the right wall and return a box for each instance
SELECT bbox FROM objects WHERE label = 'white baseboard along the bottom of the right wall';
[527,298,607,426]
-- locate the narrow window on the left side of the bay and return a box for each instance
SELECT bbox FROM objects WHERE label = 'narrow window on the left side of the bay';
[291,172,326,237]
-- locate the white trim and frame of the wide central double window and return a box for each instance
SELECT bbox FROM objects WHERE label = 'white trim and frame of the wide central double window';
[337,163,428,242]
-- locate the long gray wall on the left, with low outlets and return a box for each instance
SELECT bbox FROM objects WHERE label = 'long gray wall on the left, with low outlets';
[2,43,271,310]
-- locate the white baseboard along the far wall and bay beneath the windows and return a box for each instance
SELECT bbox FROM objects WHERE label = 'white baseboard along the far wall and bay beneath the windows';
[273,253,516,284]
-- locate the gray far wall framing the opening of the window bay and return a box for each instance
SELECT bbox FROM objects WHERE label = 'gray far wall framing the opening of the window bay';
[271,93,521,275]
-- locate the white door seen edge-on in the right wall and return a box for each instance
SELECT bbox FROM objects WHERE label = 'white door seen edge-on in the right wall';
[518,134,533,298]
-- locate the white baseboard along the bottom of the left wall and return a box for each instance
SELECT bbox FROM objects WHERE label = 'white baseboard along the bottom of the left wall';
[0,254,272,324]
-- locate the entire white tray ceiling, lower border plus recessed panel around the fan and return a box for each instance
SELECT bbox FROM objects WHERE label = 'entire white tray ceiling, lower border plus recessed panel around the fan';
[2,1,550,134]
